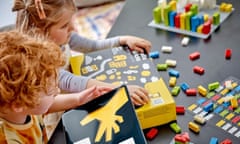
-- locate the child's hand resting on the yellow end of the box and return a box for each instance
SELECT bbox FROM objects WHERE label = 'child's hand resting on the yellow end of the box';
[127,85,149,106]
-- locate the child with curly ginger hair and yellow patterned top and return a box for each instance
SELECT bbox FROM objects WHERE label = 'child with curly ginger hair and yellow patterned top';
[0,31,114,144]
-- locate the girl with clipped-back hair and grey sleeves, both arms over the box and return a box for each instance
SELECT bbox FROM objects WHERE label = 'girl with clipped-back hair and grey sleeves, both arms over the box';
[13,0,151,105]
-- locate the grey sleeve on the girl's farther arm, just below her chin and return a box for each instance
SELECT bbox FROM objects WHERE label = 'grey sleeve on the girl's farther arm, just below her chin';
[69,32,120,53]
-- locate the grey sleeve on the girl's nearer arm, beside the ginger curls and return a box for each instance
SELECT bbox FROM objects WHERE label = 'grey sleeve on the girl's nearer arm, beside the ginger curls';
[59,69,90,92]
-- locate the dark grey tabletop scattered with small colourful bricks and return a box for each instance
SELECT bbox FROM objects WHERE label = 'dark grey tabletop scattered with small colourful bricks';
[108,0,240,144]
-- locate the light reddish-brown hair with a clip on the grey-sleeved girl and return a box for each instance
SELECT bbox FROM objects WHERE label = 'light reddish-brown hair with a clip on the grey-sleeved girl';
[12,0,76,34]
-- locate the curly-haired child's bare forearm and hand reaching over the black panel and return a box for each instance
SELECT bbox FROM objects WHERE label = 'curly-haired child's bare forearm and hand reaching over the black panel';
[48,86,112,113]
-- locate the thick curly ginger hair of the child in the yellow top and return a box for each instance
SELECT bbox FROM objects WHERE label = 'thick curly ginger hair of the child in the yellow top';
[0,30,65,109]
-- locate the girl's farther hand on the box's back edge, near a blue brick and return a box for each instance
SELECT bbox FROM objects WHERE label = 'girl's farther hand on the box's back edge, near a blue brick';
[120,36,151,54]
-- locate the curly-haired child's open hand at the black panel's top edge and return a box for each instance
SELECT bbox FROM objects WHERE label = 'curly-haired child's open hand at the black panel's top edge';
[78,86,112,105]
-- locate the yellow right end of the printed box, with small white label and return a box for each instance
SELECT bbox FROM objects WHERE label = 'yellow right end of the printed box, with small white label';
[136,78,177,129]
